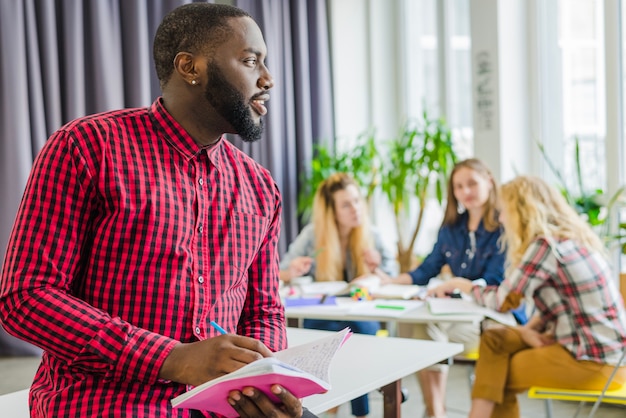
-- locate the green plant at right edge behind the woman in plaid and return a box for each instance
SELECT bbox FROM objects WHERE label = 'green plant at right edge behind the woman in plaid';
[537,138,626,254]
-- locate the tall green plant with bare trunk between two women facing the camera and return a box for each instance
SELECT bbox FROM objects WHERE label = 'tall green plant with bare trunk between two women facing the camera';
[380,112,457,271]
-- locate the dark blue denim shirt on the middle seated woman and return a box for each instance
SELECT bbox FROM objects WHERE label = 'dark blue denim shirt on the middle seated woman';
[409,213,505,285]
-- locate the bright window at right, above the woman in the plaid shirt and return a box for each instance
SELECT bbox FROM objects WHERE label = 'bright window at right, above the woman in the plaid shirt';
[531,0,607,191]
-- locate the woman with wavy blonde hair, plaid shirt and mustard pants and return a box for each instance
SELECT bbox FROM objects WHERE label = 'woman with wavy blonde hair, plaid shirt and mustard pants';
[436,176,626,418]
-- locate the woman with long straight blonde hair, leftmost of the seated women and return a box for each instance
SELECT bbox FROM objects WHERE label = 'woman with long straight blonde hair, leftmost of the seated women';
[280,173,396,417]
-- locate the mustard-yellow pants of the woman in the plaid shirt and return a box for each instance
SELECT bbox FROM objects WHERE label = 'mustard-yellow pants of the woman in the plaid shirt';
[472,327,626,418]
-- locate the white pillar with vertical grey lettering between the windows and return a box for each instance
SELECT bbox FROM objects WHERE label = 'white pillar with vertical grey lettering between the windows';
[470,0,532,181]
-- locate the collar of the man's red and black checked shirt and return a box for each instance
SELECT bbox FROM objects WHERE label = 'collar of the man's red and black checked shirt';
[150,97,225,170]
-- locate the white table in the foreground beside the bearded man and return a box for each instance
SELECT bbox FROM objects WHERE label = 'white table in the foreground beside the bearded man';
[287,328,463,418]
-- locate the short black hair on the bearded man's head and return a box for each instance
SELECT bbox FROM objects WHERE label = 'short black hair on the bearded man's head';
[152,3,251,87]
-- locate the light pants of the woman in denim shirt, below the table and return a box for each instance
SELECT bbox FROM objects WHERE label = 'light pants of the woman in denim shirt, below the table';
[398,322,480,372]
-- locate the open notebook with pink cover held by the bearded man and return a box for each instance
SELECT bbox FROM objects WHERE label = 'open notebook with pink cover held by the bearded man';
[172,328,352,417]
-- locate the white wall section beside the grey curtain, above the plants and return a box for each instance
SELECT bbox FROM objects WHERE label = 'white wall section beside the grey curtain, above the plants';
[329,0,403,141]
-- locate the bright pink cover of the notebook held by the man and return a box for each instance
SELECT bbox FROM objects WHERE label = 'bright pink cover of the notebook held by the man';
[174,373,328,417]
